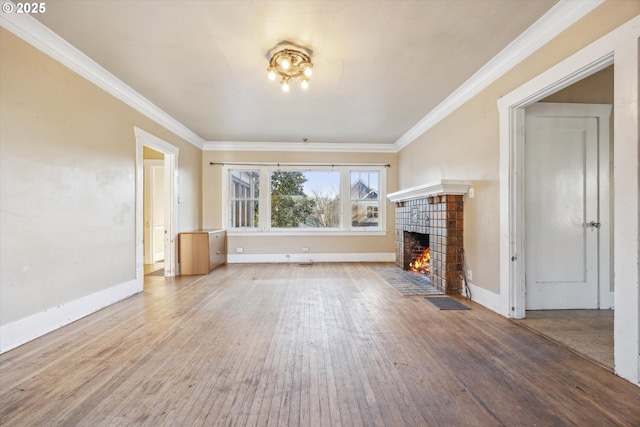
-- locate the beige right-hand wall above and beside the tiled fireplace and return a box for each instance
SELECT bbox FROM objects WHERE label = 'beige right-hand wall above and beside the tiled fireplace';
[398,1,640,293]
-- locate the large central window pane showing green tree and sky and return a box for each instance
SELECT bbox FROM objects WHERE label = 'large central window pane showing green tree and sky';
[271,171,340,228]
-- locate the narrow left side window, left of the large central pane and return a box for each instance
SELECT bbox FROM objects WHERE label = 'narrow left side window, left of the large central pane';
[229,170,260,228]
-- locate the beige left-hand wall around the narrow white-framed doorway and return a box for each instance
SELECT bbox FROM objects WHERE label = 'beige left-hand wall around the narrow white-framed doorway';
[0,28,202,325]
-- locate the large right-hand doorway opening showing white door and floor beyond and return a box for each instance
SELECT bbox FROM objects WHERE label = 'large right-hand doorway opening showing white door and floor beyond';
[522,66,614,370]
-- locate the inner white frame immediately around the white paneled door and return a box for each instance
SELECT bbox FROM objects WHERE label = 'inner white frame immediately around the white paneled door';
[514,102,614,311]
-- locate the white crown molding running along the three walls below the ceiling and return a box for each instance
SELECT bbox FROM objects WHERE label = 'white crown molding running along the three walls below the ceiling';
[0,0,604,153]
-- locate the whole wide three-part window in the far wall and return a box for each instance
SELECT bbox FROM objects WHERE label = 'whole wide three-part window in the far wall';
[225,165,386,234]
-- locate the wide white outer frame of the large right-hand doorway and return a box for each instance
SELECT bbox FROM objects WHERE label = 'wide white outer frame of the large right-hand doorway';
[497,16,640,384]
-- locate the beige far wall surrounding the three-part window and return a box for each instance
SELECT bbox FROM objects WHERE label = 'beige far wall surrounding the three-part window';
[202,151,398,255]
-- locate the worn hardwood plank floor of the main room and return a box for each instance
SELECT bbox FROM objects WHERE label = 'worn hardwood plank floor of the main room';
[0,264,640,426]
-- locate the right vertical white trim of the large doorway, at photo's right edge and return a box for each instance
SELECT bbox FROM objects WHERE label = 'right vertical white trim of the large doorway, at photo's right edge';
[613,25,640,385]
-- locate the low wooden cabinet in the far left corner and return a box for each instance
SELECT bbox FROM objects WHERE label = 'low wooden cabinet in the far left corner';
[178,230,227,274]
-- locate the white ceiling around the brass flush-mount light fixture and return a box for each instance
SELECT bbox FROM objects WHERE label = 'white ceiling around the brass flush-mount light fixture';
[34,0,556,145]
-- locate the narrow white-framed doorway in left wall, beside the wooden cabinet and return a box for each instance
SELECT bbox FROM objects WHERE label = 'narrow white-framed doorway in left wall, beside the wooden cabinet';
[134,127,179,286]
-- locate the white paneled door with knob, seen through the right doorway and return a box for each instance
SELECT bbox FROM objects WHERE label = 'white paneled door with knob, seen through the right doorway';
[525,110,599,310]
